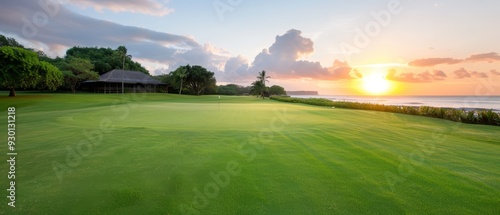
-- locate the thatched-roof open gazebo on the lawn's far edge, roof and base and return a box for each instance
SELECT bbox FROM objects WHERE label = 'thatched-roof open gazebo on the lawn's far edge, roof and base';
[82,69,165,93]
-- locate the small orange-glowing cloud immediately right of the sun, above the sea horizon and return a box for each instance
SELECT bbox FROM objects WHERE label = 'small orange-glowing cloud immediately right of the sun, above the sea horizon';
[385,69,447,83]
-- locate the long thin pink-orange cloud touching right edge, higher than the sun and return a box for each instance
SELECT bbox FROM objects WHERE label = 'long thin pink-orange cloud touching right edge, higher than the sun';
[408,52,500,67]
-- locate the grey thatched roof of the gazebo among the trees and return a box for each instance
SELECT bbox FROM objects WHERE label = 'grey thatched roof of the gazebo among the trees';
[86,69,162,84]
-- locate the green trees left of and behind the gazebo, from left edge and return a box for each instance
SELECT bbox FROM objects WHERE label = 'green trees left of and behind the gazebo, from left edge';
[0,35,149,96]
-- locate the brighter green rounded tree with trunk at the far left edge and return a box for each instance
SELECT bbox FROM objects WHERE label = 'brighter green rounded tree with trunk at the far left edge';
[0,46,40,96]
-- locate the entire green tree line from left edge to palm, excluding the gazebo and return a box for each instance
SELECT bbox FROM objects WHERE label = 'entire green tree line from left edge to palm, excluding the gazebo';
[0,34,286,98]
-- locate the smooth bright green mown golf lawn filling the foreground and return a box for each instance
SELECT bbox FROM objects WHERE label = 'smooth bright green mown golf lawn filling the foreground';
[0,92,500,214]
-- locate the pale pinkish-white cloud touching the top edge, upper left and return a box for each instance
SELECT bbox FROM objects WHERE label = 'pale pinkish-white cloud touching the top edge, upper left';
[63,0,174,16]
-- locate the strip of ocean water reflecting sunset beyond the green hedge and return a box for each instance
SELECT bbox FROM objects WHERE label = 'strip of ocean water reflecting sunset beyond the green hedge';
[292,95,500,112]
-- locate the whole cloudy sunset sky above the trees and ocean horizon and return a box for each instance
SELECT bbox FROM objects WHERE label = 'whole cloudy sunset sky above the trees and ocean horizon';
[0,0,500,96]
